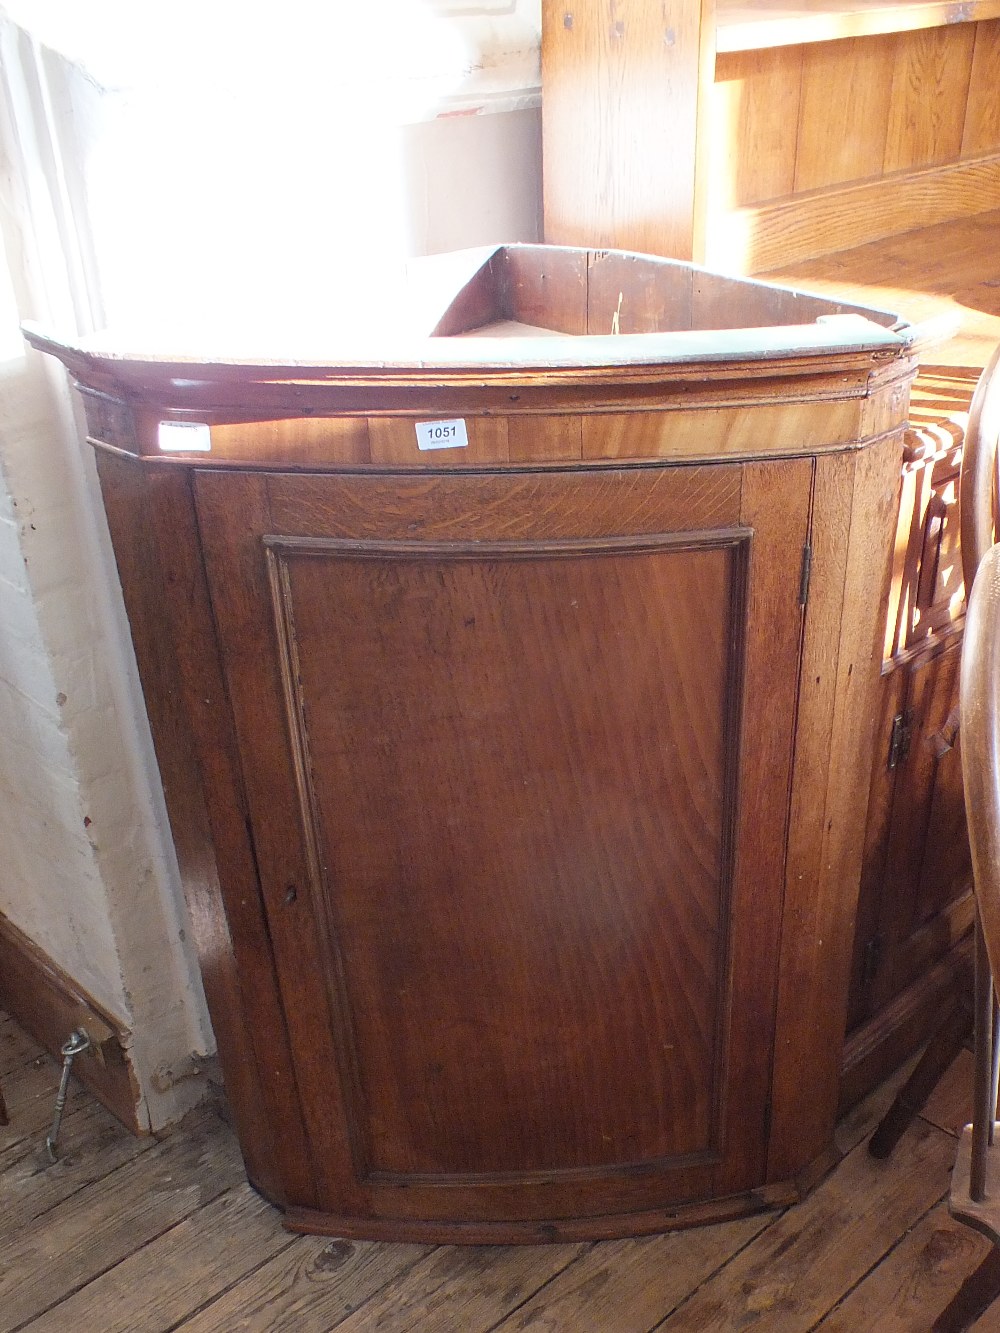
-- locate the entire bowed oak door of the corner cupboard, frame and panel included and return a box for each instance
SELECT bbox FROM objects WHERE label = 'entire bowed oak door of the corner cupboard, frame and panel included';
[196,463,811,1224]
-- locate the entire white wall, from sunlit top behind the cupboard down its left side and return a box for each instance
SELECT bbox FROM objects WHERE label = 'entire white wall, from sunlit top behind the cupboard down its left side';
[0,0,541,1126]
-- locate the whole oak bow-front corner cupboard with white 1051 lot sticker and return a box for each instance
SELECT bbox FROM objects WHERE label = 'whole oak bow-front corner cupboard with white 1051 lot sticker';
[28,247,915,1241]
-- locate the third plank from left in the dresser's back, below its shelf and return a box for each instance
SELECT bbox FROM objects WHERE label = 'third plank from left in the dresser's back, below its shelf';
[883,24,976,173]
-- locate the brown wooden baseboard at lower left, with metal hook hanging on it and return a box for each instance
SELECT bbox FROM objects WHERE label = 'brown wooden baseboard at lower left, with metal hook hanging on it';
[0,913,147,1134]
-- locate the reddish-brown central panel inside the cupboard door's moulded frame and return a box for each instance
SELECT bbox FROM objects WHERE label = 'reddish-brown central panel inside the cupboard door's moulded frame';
[281,533,739,1178]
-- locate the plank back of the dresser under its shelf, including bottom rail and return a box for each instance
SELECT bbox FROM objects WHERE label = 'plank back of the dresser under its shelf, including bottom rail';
[704,19,1000,272]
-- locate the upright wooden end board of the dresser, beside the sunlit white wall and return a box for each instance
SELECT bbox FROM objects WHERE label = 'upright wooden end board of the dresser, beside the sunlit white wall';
[541,0,715,259]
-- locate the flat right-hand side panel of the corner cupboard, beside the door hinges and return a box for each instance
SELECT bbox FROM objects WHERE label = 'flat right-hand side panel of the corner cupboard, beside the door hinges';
[768,431,903,1180]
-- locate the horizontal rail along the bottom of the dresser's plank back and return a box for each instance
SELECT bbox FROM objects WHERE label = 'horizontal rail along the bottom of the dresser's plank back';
[705,156,1000,273]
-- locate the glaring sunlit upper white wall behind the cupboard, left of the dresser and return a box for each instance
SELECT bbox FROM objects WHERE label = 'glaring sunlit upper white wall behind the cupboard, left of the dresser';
[8,0,541,327]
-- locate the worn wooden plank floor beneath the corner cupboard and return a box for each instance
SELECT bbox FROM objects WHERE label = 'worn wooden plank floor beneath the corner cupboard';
[0,1016,1000,1333]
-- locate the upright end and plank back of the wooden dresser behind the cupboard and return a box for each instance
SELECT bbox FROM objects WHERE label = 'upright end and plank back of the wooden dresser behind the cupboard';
[543,0,1000,273]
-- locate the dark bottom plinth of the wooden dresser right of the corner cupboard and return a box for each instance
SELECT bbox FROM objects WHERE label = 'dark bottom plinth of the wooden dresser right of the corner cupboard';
[839,936,972,1116]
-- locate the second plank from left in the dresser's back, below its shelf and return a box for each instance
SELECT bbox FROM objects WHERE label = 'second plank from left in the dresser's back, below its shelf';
[794,37,896,193]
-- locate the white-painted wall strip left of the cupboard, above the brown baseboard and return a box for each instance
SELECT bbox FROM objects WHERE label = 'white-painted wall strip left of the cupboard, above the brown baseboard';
[0,51,211,1128]
